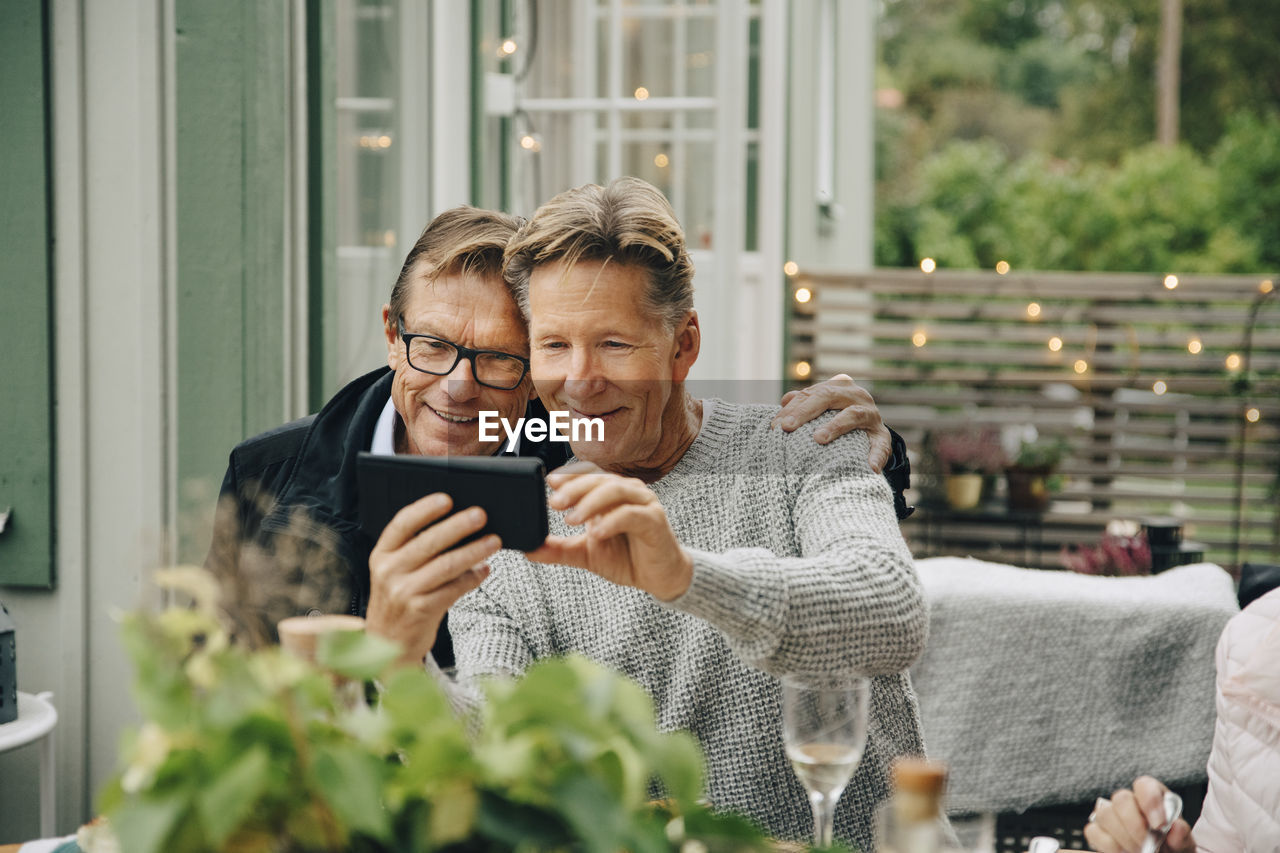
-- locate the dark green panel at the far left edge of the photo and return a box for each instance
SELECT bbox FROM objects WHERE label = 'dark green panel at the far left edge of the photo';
[0,0,54,588]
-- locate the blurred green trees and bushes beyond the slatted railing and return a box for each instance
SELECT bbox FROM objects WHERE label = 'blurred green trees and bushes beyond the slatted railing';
[876,0,1280,273]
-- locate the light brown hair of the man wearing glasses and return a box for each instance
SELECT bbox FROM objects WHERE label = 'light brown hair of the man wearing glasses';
[390,205,525,321]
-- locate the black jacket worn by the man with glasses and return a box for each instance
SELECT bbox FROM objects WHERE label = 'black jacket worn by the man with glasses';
[205,368,910,666]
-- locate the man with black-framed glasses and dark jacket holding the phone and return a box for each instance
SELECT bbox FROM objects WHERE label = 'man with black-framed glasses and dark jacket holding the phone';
[206,207,901,666]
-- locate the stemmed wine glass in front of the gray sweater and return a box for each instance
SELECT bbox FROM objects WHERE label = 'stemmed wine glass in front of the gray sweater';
[782,678,872,847]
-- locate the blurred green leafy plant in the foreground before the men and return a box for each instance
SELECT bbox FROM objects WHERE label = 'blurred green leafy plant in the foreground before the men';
[100,567,764,853]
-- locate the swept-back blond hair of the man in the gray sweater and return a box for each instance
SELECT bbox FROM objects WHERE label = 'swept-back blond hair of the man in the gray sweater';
[503,178,694,329]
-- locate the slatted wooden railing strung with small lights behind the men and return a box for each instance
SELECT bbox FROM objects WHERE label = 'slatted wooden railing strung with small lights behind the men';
[788,270,1280,566]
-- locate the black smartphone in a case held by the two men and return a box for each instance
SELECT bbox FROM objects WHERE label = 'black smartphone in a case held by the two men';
[356,453,547,551]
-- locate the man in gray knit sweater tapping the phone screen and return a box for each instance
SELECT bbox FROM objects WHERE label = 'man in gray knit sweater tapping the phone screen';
[451,178,928,850]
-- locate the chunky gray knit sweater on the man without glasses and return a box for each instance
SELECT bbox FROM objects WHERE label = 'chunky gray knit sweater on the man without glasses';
[449,401,928,850]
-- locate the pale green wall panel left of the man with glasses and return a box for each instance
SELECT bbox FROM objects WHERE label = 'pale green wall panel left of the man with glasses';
[175,0,292,561]
